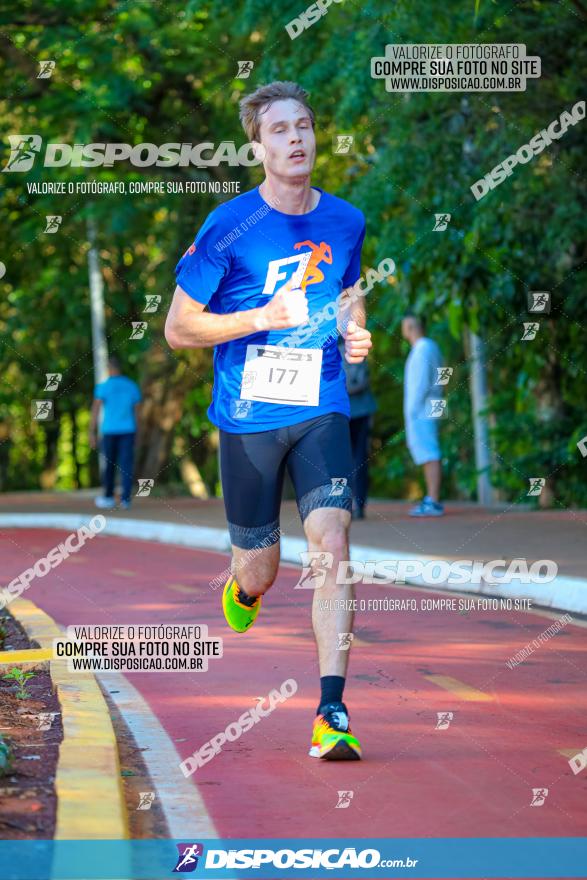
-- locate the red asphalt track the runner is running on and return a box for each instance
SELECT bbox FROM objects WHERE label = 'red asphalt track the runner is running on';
[0,529,587,841]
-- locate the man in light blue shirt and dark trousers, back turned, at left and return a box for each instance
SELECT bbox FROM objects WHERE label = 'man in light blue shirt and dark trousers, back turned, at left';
[90,355,141,510]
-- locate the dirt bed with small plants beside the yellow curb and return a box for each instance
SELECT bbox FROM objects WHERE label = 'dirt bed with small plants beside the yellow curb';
[0,612,63,840]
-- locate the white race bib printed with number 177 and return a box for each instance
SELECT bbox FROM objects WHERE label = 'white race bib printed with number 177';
[241,345,322,406]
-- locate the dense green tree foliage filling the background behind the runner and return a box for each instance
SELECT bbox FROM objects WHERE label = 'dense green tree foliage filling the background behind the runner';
[0,0,587,506]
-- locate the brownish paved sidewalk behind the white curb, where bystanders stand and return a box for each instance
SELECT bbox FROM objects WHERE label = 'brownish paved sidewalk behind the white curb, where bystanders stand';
[0,492,587,578]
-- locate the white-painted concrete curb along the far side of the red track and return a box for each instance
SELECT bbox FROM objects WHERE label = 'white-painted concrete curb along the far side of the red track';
[0,512,587,615]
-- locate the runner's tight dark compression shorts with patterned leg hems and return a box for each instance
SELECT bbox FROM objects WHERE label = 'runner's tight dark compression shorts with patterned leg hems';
[220,413,352,550]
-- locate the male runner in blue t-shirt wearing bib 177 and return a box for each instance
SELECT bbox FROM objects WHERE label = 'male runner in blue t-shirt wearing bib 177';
[165,82,371,760]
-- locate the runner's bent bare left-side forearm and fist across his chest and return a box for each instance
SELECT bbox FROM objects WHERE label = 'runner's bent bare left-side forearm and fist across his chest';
[165,285,308,348]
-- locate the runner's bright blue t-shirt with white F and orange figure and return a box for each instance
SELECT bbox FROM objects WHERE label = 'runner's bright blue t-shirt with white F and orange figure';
[175,187,365,434]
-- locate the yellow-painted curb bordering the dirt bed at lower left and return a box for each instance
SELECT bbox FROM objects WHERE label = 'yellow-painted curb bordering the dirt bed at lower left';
[5,599,129,840]
